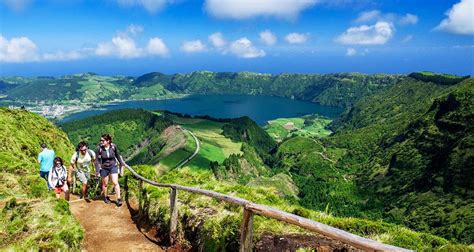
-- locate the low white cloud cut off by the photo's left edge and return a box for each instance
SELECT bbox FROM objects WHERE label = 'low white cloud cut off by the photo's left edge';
[0,35,40,63]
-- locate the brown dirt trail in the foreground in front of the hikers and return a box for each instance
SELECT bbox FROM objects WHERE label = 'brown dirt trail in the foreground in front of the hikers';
[70,197,164,251]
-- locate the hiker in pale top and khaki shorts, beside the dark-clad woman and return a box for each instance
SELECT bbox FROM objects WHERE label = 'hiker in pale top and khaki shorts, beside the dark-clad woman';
[67,141,95,200]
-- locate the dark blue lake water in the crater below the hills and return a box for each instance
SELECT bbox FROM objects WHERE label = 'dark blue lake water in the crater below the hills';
[62,95,342,125]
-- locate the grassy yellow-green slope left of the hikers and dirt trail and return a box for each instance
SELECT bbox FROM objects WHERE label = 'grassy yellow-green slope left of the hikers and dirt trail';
[0,108,83,251]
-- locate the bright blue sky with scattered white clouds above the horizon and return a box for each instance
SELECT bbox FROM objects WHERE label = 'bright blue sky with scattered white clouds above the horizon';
[0,0,474,76]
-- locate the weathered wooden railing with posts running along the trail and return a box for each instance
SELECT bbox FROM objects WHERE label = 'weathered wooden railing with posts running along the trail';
[125,165,410,252]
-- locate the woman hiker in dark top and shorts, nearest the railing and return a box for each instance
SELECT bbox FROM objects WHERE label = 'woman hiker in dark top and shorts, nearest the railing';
[95,134,125,206]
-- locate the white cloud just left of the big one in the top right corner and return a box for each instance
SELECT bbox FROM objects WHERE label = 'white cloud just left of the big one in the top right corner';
[336,22,394,45]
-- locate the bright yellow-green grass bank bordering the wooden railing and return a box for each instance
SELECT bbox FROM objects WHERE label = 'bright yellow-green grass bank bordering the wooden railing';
[124,166,473,251]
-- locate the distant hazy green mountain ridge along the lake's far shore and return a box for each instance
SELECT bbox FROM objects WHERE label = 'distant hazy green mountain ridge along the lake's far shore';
[0,71,405,107]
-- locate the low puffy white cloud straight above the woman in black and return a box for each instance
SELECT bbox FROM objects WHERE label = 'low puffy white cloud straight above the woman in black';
[95,35,143,58]
